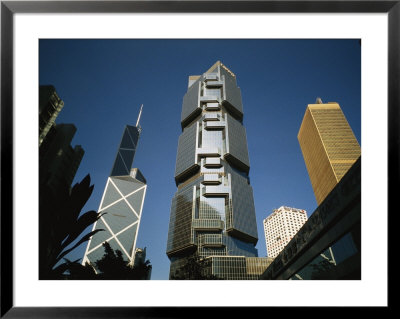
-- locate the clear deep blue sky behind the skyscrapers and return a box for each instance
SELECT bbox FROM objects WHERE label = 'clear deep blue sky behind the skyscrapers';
[39,39,361,280]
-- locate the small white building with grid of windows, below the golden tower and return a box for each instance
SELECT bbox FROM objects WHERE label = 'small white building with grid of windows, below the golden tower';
[263,206,307,258]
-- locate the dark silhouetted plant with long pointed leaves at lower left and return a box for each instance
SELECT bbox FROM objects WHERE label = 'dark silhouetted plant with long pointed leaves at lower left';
[39,174,102,279]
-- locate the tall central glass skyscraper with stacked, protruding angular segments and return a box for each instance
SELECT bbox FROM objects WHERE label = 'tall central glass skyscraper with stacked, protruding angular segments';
[167,61,266,279]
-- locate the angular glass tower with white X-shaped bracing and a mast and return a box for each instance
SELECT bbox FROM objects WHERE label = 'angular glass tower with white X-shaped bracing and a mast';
[82,108,147,267]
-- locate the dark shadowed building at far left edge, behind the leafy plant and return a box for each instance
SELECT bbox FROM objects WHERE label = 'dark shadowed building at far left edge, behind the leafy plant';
[38,85,85,279]
